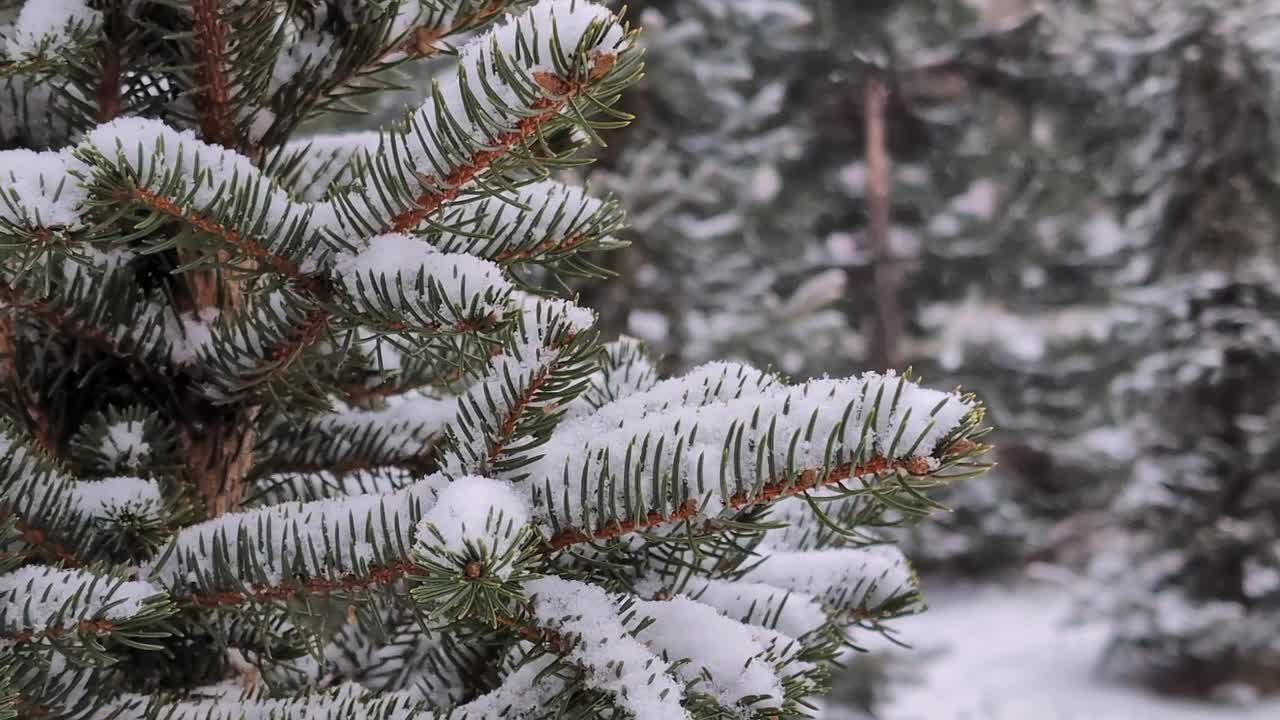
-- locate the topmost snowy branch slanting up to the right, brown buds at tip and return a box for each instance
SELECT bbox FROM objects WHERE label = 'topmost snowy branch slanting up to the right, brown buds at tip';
[338,0,639,237]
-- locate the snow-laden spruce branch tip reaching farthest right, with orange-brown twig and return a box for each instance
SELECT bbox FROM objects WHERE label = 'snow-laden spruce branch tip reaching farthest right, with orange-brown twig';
[524,373,980,544]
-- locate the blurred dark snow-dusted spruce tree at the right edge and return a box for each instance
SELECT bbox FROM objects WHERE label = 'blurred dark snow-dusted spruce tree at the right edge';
[1055,0,1280,694]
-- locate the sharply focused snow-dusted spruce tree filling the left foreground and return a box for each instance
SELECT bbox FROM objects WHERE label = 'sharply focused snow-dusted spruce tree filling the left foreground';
[0,0,986,720]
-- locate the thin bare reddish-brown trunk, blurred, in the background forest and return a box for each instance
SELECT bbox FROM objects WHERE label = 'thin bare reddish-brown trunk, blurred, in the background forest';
[863,77,902,370]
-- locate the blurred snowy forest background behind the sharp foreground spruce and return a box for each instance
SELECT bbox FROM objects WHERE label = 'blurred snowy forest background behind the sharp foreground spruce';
[317,0,1280,720]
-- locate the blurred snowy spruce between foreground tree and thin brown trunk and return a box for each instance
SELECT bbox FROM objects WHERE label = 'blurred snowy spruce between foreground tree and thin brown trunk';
[590,0,854,377]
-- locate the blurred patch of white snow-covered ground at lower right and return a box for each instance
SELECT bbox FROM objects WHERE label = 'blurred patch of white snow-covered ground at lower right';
[860,583,1280,720]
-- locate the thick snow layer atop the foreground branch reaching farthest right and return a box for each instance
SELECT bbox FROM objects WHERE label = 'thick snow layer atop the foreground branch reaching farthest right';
[521,373,972,528]
